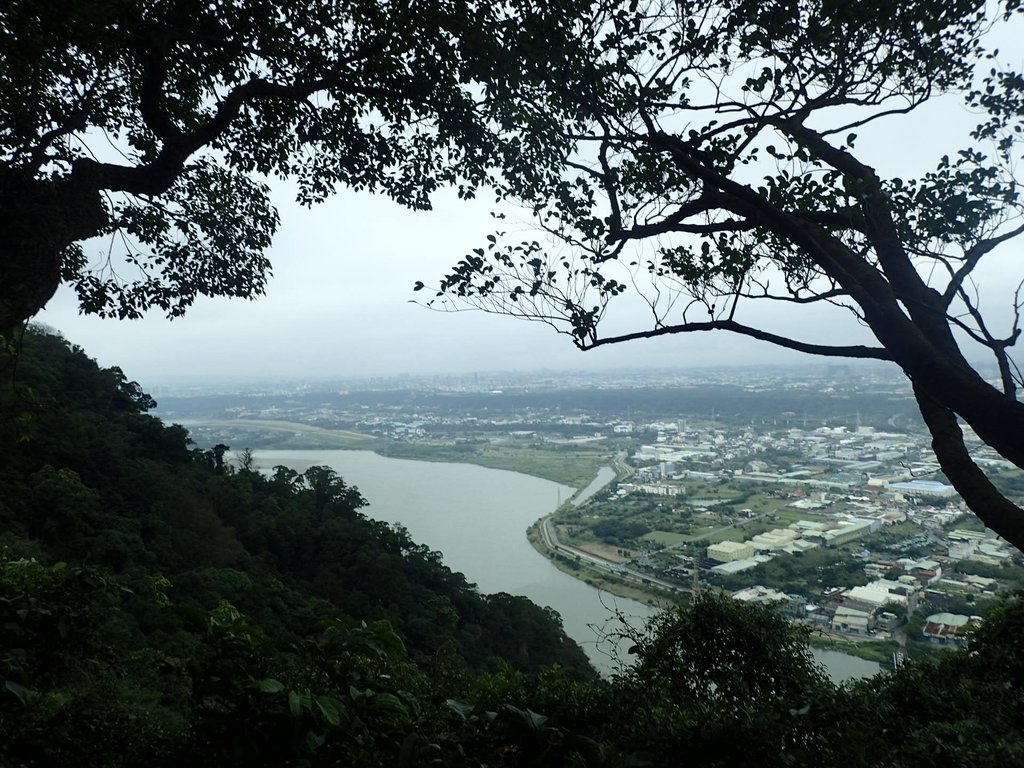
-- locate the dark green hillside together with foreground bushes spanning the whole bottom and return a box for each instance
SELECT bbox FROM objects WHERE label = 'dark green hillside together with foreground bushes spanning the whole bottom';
[0,330,1024,768]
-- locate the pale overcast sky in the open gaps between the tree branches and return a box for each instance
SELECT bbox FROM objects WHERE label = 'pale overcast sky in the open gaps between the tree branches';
[37,34,1024,387]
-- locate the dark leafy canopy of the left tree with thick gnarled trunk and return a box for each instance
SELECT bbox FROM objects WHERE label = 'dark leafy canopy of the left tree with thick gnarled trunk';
[0,0,586,330]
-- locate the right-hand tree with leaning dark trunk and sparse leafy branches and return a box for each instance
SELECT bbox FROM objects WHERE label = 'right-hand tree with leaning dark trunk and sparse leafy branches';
[429,0,1024,549]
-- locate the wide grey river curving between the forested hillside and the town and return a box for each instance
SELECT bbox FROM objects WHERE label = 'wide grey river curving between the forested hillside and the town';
[254,451,878,680]
